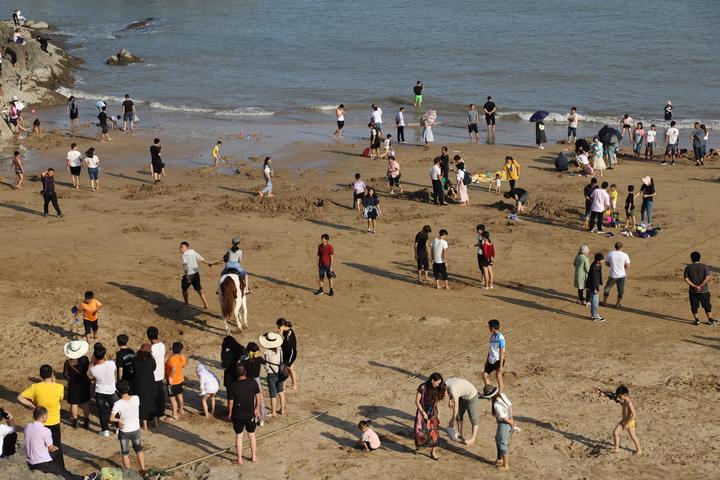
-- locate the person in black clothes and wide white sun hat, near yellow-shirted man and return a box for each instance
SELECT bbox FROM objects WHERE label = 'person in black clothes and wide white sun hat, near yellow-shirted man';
[63,340,91,430]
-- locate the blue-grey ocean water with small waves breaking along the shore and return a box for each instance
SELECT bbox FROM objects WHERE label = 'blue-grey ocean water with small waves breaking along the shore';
[7,0,720,148]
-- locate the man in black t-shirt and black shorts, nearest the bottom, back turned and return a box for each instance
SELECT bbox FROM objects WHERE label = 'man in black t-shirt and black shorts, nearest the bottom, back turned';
[228,365,262,465]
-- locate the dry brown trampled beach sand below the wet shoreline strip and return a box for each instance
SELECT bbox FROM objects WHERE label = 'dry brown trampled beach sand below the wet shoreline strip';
[0,129,720,479]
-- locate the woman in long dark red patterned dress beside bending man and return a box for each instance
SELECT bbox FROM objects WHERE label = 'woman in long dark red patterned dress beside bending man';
[415,372,447,460]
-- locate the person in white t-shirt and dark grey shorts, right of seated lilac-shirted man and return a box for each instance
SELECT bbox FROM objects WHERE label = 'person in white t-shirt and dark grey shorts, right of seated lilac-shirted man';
[110,380,147,476]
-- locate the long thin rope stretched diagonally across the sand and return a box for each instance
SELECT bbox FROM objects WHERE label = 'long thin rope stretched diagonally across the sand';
[153,234,717,479]
